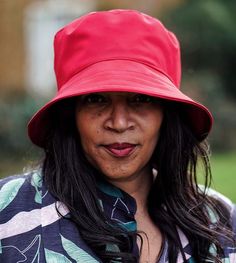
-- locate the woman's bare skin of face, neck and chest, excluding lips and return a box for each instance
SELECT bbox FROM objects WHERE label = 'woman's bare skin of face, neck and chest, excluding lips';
[75,92,163,262]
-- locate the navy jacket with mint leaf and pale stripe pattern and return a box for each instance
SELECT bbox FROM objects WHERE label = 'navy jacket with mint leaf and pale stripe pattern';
[0,171,236,263]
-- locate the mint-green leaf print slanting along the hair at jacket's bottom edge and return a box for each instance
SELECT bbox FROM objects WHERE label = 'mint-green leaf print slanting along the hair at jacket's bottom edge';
[61,235,99,263]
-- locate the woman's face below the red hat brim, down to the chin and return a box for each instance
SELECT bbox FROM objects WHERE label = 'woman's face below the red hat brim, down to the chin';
[76,92,163,182]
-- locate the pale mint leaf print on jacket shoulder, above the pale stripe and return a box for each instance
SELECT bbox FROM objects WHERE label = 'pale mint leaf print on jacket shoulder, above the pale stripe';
[0,178,25,212]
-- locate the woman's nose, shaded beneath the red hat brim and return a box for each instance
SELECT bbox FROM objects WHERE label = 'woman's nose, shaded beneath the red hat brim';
[104,101,134,133]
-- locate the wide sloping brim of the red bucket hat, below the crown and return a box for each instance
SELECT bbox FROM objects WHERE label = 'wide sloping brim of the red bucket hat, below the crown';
[28,59,213,148]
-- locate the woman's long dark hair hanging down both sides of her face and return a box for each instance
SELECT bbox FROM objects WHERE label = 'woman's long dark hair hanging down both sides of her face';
[43,99,233,263]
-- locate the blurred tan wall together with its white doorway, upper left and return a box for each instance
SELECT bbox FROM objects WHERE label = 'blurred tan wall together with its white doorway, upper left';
[0,0,96,96]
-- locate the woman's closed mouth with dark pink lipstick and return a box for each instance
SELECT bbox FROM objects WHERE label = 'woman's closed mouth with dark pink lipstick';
[103,143,138,157]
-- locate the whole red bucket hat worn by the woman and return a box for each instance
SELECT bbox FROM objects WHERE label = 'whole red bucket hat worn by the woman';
[28,10,212,147]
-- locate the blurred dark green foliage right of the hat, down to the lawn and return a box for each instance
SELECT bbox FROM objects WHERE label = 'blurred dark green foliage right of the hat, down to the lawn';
[162,0,236,151]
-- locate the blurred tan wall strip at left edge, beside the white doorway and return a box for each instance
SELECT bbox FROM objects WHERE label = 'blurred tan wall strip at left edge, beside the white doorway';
[0,0,30,95]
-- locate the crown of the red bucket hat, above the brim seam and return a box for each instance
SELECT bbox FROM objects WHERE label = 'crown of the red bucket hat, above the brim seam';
[54,9,181,89]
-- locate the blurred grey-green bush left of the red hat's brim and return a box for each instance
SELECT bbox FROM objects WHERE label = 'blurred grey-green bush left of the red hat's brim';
[0,93,42,158]
